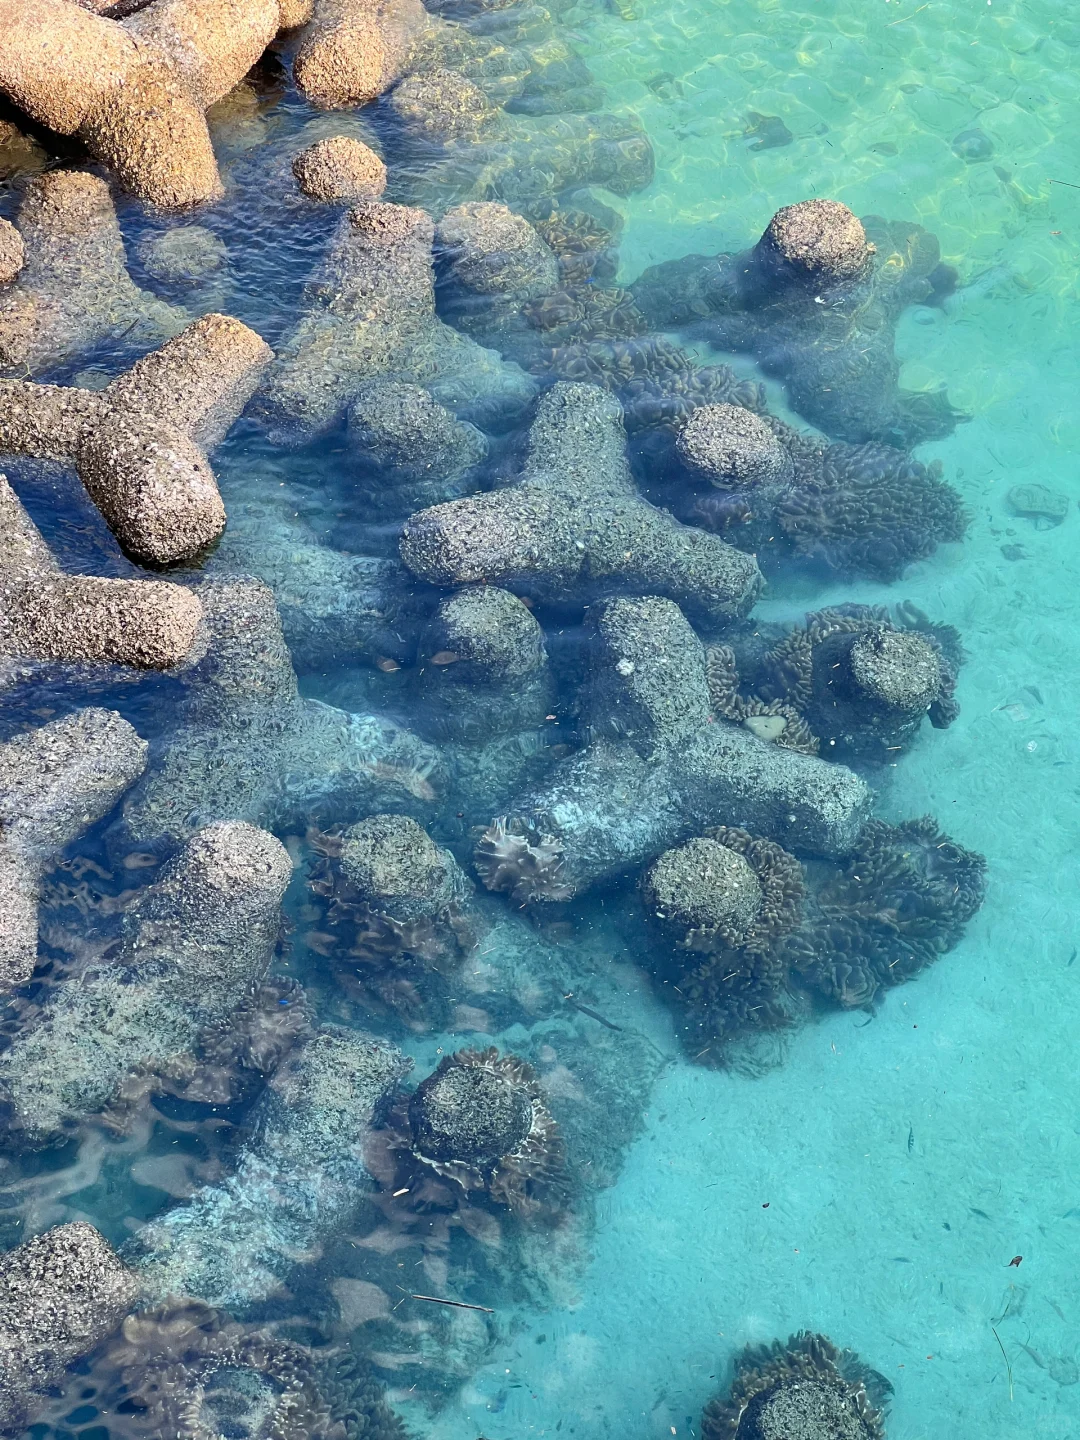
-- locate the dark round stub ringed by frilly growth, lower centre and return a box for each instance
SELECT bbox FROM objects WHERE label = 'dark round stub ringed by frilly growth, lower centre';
[409,1047,563,1214]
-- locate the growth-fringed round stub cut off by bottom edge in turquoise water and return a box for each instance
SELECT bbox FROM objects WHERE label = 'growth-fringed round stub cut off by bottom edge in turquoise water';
[701,1331,891,1440]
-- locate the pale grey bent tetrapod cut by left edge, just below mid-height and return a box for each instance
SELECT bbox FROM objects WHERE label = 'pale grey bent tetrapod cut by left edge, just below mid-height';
[0,710,147,995]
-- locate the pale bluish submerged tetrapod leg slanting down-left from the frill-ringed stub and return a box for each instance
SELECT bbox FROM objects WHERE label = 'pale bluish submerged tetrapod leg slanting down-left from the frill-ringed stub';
[124,1025,412,1310]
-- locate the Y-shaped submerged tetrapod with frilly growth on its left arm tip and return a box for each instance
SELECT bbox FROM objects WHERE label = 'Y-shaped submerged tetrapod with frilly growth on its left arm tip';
[477,596,871,901]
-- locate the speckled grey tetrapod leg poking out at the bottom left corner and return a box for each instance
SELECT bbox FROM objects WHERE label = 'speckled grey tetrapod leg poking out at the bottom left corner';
[0,1220,138,1434]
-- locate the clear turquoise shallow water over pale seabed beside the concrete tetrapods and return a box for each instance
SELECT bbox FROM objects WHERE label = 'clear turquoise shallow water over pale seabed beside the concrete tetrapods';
[6,0,1080,1440]
